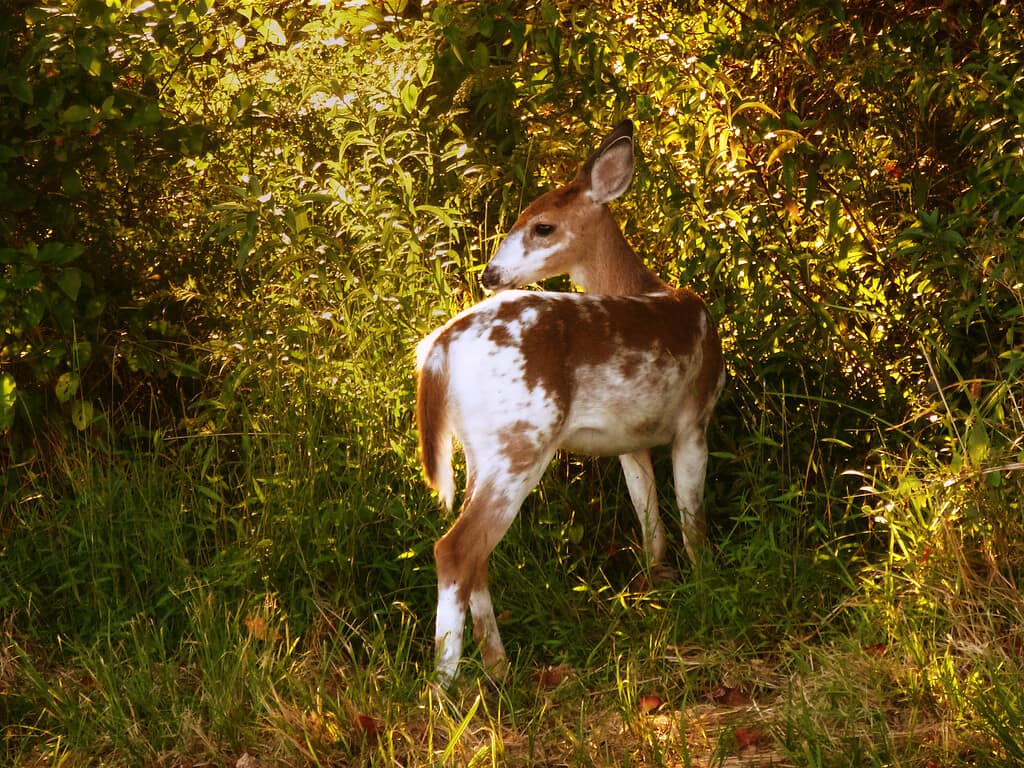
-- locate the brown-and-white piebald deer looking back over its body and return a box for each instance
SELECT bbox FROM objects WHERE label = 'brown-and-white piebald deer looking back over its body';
[417,121,725,684]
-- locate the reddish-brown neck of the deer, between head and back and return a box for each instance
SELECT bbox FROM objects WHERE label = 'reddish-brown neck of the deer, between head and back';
[569,207,670,296]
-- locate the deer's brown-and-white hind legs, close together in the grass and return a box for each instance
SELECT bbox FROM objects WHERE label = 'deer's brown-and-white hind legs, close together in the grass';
[434,453,552,685]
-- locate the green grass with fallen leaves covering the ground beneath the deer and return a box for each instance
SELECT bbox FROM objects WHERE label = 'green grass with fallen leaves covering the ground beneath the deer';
[0,393,1024,766]
